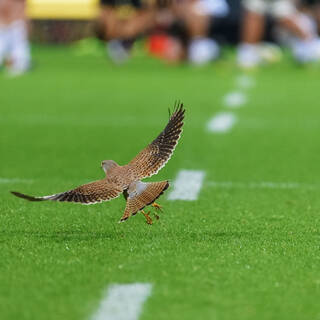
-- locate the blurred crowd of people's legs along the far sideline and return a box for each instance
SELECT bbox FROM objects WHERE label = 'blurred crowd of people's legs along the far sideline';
[0,0,320,74]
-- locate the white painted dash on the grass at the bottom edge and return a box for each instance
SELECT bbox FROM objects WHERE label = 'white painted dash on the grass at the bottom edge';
[92,283,152,320]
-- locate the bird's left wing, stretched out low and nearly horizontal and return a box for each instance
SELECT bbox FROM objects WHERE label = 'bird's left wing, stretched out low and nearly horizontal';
[11,179,123,204]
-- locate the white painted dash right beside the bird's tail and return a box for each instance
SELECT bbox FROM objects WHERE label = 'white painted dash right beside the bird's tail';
[168,170,205,201]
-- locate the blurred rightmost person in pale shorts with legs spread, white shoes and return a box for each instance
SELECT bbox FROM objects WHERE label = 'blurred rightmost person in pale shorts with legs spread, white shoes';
[237,0,317,68]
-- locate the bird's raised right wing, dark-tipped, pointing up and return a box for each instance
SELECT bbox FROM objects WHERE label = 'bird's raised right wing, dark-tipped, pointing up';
[128,103,185,180]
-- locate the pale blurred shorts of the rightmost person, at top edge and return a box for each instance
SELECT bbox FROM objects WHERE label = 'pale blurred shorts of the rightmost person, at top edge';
[243,0,297,18]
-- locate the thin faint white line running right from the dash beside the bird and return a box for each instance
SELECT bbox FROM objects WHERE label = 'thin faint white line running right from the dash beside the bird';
[206,181,316,189]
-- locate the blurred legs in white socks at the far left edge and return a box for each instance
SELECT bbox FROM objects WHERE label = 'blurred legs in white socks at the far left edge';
[0,0,31,75]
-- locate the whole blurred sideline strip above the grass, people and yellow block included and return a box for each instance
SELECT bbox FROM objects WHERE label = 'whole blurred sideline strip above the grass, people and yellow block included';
[0,0,320,75]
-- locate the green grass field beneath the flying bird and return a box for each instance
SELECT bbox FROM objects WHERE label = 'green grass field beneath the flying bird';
[0,48,320,320]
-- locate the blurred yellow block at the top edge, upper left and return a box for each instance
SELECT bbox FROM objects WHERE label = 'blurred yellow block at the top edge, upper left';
[27,0,99,20]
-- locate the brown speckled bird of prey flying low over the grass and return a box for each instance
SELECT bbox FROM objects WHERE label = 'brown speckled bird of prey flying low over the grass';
[11,103,185,224]
